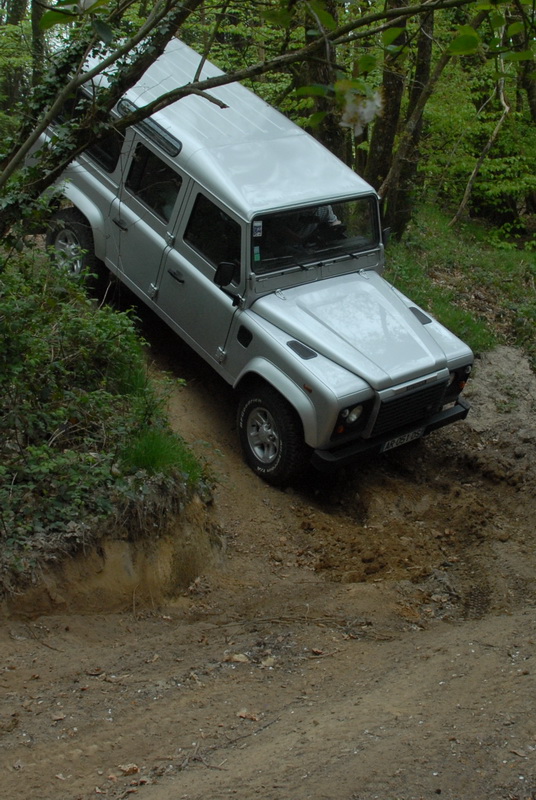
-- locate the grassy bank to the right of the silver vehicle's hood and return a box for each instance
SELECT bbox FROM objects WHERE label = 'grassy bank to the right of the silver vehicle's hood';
[386,202,536,368]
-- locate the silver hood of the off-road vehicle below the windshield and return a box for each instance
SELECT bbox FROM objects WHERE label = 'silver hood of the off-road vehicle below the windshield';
[251,270,456,390]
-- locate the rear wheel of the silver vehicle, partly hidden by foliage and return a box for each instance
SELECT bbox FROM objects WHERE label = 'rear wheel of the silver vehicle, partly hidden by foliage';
[46,208,99,275]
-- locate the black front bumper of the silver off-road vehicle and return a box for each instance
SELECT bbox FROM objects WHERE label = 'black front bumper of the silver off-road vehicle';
[311,397,471,470]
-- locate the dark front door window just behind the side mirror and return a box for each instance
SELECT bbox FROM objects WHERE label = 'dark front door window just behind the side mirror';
[184,194,240,267]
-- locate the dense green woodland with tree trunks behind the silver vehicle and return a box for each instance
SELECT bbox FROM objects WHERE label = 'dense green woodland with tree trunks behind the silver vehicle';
[0,0,536,241]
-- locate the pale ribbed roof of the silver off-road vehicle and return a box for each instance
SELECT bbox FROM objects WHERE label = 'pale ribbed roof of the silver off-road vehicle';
[115,39,374,219]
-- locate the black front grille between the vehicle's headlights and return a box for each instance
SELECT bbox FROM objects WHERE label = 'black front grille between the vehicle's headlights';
[370,382,447,437]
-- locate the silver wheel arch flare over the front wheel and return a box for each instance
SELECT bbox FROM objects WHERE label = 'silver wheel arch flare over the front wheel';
[233,357,317,446]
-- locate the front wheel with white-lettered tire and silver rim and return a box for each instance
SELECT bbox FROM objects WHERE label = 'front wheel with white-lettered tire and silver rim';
[238,386,307,486]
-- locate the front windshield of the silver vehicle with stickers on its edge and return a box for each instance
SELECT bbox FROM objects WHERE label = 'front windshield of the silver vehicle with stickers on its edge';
[252,195,379,274]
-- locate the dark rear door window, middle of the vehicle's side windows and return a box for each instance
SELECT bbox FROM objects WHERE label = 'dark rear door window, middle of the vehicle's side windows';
[126,144,182,222]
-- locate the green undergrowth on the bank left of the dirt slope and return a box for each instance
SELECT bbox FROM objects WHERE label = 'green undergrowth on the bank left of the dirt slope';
[0,245,202,588]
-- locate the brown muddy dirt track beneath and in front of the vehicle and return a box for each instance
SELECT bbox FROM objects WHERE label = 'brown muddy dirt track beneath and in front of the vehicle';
[0,324,536,800]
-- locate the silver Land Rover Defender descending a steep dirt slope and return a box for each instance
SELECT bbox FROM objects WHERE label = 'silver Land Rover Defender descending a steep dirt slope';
[48,40,473,484]
